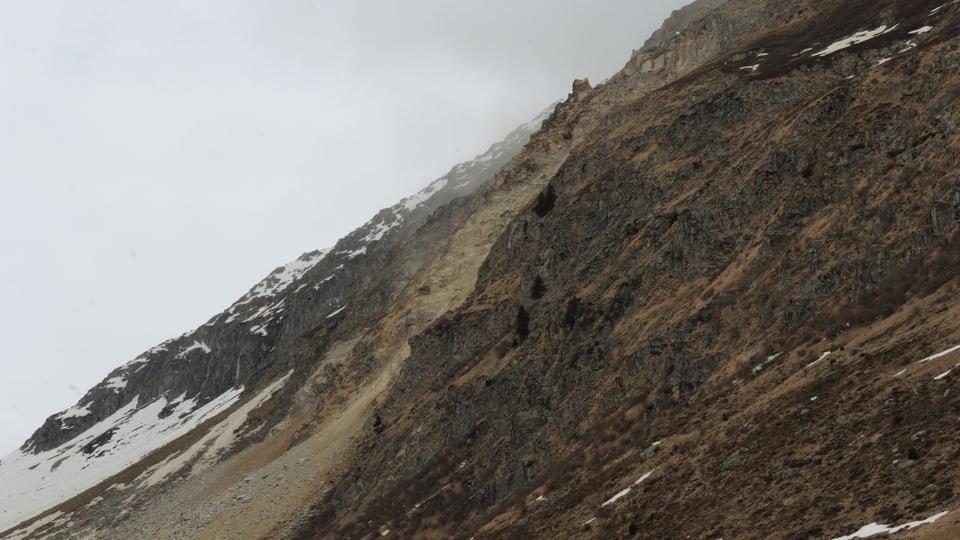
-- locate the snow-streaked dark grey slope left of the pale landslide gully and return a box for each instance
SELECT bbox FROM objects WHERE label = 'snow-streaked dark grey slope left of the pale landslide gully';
[0,107,546,529]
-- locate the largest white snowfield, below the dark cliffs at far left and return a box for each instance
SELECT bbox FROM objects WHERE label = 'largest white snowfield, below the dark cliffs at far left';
[0,387,243,531]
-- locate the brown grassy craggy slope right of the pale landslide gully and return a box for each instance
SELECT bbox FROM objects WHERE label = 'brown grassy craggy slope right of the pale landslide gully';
[286,2,957,538]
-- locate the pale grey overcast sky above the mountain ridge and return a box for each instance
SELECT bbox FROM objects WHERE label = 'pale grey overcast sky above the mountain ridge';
[0,0,686,457]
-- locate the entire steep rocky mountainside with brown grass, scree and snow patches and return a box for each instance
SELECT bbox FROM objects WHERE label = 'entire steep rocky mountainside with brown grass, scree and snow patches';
[0,0,960,540]
